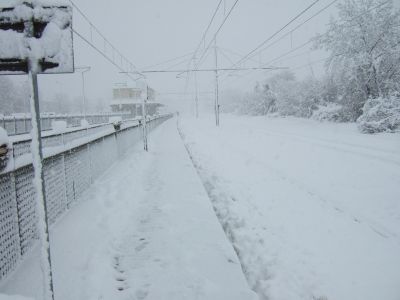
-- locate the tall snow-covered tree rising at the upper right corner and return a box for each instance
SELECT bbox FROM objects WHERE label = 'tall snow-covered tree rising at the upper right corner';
[316,0,400,120]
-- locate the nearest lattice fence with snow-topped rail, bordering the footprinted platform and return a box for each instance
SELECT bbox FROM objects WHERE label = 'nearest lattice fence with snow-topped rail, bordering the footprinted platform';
[0,115,172,281]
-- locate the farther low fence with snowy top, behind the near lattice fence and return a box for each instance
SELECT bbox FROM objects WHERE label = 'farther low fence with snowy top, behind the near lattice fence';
[0,113,132,135]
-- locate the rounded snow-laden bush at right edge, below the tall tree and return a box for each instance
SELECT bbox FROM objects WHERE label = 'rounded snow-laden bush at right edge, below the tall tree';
[357,94,400,133]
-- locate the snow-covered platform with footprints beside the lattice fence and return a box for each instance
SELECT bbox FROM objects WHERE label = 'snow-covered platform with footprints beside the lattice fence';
[0,120,257,300]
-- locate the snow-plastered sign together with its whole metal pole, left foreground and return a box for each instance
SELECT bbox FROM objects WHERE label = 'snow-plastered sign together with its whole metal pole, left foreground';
[0,0,74,300]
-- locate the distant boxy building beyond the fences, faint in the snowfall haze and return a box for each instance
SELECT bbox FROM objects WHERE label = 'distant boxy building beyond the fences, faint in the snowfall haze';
[110,86,162,117]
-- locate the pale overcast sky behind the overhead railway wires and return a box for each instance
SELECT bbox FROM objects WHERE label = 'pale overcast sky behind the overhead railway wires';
[36,0,335,110]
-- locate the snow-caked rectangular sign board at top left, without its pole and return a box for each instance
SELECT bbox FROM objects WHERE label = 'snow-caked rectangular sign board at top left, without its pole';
[0,0,74,75]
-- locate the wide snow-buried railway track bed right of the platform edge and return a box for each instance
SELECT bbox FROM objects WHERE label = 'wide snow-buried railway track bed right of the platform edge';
[180,115,400,300]
